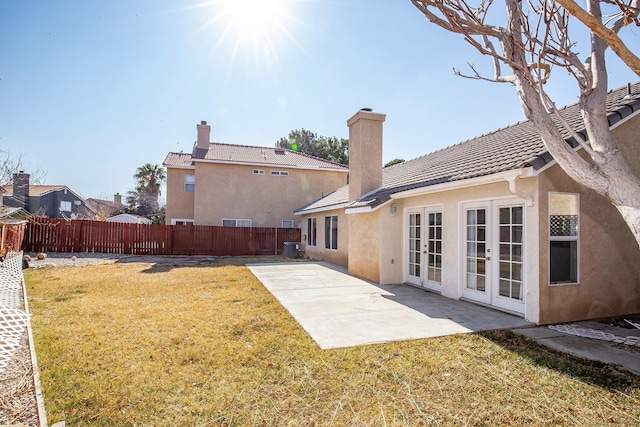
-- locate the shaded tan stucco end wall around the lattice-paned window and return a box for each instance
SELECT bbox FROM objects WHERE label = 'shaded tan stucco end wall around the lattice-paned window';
[539,115,640,324]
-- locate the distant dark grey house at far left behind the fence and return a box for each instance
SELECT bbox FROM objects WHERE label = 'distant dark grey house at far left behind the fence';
[2,171,93,219]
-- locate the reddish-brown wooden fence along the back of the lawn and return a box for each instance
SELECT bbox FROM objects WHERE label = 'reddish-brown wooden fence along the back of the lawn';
[22,217,300,256]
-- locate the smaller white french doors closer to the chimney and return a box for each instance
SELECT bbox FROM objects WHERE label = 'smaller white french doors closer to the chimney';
[405,208,442,292]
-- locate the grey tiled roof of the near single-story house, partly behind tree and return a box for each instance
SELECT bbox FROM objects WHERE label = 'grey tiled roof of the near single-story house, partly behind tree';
[296,82,640,214]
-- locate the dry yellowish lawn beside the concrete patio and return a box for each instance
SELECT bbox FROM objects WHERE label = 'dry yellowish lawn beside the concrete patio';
[25,259,640,426]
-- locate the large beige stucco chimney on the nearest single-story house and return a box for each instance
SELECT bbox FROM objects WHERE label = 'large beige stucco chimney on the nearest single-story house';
[347,108,386,202]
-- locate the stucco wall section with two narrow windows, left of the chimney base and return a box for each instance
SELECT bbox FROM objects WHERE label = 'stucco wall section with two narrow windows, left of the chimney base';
[302,209,349,267]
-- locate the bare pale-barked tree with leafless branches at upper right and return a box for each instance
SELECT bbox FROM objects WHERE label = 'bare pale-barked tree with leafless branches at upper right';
[411,0,640,246]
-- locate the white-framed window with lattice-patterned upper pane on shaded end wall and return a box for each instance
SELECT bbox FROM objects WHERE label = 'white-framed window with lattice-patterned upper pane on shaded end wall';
[549,193,580,285]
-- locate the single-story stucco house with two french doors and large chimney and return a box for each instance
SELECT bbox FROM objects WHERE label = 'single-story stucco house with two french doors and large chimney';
[295,83,640,324]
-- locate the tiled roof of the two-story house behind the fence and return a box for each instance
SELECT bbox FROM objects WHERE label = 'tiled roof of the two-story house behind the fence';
[163,143,349,172]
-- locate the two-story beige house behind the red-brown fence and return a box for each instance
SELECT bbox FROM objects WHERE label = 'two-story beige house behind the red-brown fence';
[163,121,348,227]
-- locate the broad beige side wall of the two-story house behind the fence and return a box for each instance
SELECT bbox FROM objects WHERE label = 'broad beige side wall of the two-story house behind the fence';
[188,163,347,227]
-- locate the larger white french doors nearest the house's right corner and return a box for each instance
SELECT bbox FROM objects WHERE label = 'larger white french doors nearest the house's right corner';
[462,201,525,313]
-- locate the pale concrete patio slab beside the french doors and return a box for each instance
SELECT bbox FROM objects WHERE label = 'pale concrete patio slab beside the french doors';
[247,262,532,349]
